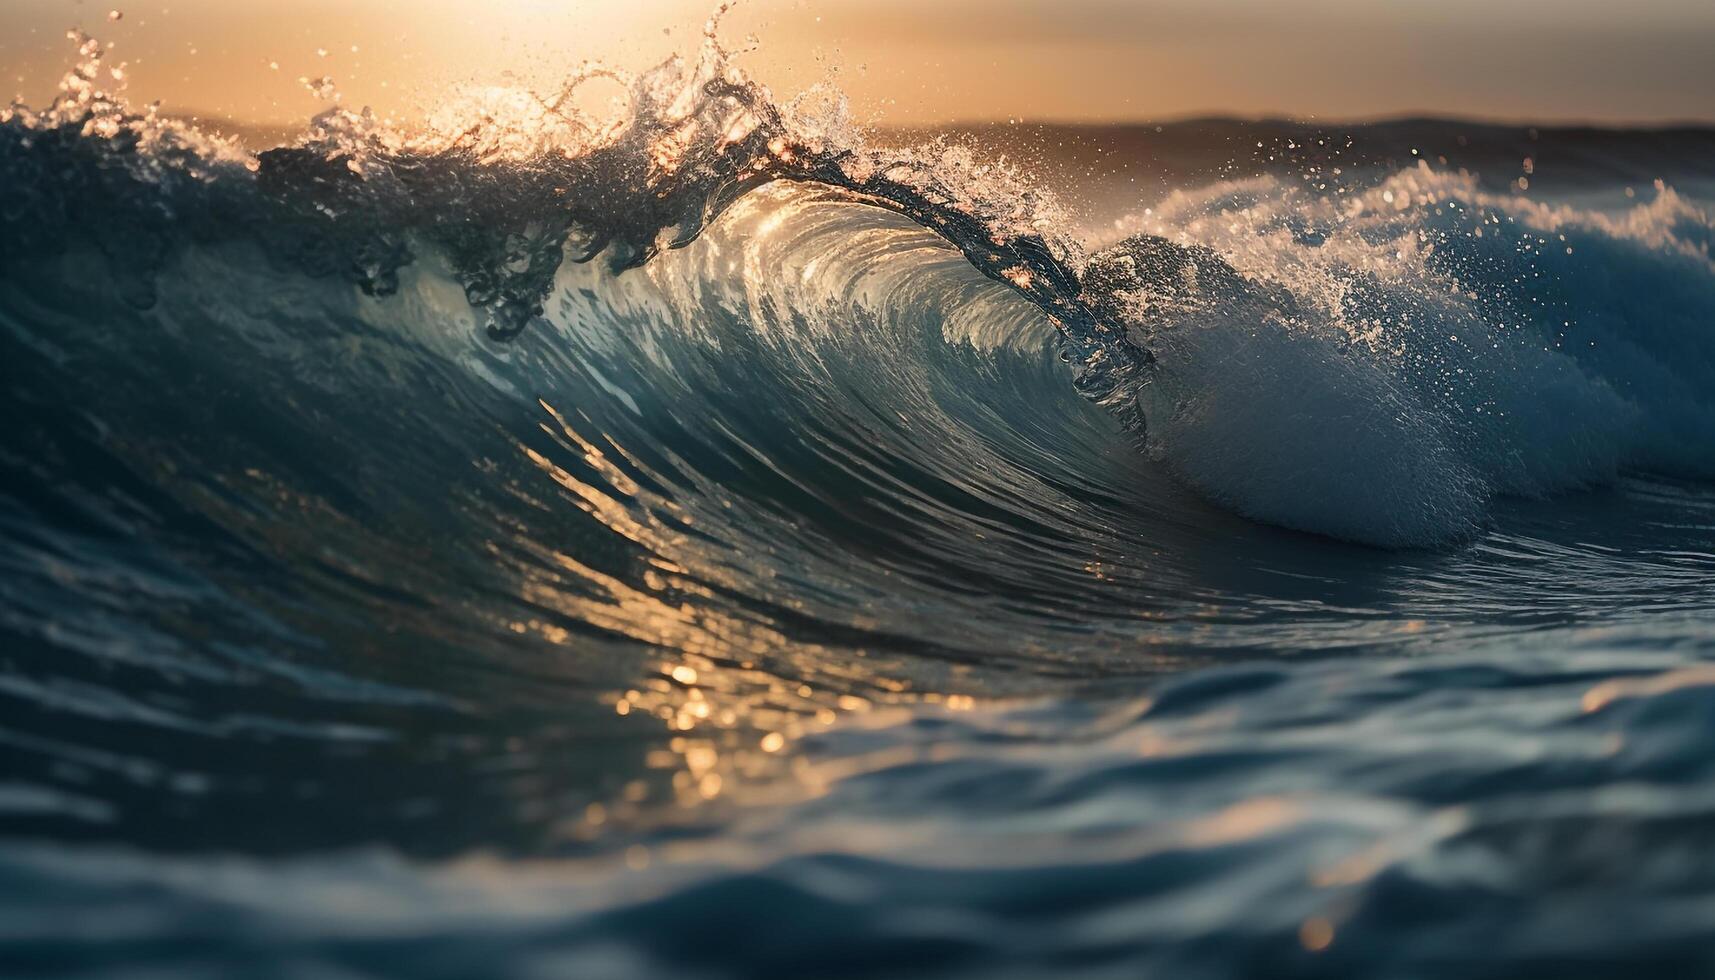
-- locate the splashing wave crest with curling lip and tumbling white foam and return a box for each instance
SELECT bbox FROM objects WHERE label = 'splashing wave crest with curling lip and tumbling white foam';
[0,26,1715,547]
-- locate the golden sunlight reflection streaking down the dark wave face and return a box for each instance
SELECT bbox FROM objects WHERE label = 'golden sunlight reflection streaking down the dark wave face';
[509,394,976,816]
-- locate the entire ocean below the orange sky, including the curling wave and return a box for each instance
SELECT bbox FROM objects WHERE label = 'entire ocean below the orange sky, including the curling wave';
[0,22,1715,980]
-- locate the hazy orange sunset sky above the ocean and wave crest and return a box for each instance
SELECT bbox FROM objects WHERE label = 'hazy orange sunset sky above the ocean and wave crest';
[0,0,1715,125]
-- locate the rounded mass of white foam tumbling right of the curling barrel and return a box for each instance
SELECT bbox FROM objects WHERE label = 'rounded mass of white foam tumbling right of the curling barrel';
[1104,168,1715,546]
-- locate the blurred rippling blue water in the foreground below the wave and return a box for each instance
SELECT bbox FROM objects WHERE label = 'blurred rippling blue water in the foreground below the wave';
[0,628,1715,978]
